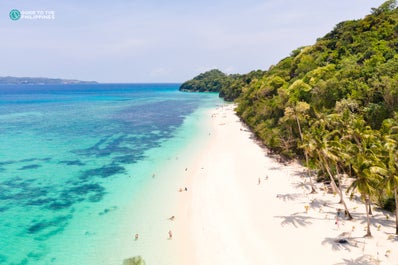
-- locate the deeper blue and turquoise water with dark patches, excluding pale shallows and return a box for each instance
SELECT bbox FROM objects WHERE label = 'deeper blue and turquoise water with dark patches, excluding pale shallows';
[0,84,216,264]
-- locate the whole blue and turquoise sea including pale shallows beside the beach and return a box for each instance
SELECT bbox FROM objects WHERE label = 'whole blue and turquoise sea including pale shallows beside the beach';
[0,84,220,265]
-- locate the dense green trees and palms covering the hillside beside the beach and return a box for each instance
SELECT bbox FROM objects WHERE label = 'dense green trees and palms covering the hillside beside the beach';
[182,0,398,231]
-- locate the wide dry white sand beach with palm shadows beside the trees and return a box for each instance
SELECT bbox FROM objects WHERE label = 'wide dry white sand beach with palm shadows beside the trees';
[172,104,398,265]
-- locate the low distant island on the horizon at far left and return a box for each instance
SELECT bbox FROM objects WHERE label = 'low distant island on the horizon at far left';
[0,76,97,85]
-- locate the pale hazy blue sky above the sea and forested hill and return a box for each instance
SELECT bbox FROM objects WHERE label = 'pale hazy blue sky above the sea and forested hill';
[0,0,384,83]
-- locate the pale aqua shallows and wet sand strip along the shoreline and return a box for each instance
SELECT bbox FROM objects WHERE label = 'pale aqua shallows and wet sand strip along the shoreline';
[96,98,222,265]
